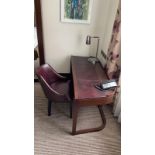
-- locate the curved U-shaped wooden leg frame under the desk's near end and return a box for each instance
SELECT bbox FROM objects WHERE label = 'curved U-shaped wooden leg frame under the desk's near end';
[72,105,106,135]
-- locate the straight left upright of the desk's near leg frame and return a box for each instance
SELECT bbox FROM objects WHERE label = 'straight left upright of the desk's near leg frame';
[72,103,79,135]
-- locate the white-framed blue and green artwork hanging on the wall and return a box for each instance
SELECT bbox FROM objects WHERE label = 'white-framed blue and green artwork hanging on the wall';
[61,0,93,24]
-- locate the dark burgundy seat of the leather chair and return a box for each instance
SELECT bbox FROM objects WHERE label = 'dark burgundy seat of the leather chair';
[50,80,71,101]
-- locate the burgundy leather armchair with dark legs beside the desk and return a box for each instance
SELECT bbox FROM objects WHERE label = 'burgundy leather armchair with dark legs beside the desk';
[36,64,72,118]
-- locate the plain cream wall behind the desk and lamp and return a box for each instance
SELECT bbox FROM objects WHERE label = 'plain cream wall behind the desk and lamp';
[41,0,119,73]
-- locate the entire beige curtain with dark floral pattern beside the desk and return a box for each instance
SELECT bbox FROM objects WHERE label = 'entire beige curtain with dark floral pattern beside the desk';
[105,0,121,122]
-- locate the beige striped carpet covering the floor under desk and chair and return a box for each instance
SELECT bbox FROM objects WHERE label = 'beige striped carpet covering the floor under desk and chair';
[34,83,121,155]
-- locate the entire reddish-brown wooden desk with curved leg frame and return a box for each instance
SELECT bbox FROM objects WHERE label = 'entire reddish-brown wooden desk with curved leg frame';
[71,56,114,135]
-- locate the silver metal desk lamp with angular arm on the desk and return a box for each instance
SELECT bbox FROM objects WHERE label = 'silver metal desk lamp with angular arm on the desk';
[86,35,100,64]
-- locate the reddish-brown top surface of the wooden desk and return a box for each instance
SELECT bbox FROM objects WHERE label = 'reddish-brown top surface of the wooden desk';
[71,56,114,100]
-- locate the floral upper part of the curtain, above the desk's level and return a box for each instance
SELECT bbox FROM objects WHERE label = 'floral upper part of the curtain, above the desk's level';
[105,1,121,79]
